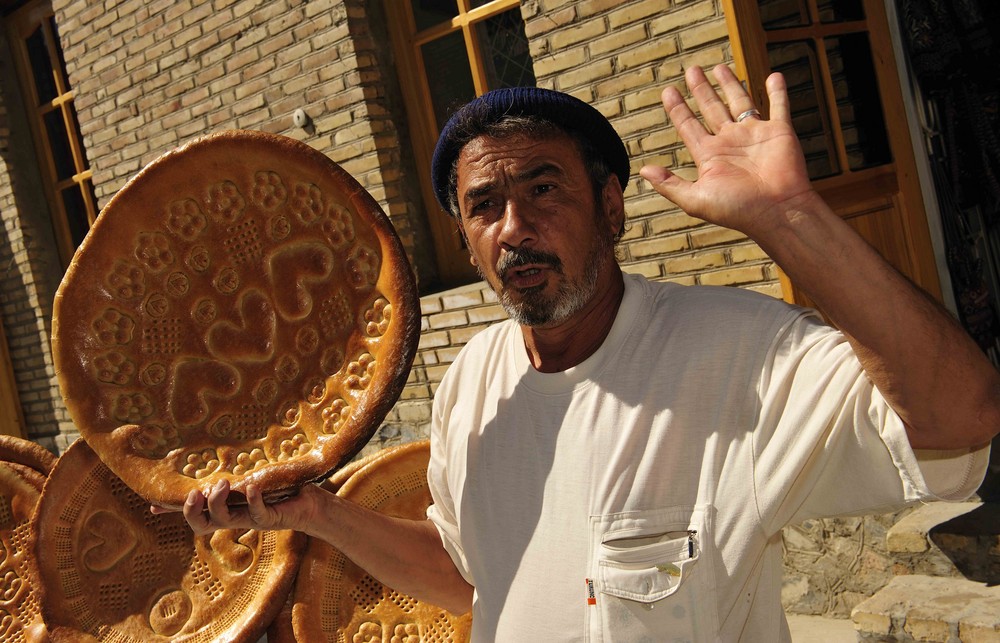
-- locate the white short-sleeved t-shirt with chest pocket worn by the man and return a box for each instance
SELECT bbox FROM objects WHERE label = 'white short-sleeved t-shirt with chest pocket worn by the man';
[428,275,988,642]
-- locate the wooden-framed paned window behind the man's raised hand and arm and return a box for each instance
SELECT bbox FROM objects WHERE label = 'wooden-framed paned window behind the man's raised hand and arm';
[723,0,941,306]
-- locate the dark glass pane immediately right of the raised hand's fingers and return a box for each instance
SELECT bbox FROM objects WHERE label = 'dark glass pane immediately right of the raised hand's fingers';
[767,41,840,179]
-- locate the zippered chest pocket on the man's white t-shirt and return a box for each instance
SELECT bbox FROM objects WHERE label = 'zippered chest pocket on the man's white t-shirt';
[588,509,718,643]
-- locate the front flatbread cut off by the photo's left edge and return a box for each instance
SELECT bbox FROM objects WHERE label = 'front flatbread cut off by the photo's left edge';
[0,462,45,643]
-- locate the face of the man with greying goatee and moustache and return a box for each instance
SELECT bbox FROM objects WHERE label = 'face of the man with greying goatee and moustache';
[458,136,622,327]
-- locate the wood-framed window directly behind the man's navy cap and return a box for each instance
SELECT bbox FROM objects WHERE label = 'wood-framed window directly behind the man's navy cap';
[385,0,535,286]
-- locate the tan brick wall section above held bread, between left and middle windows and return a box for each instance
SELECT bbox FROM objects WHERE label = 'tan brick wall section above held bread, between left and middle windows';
[54,0,429,284]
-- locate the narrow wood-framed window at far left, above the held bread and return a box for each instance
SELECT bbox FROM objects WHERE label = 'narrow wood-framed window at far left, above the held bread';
[8,0,98,267]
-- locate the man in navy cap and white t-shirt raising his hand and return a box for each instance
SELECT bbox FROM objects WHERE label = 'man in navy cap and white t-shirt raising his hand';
[176,66,1000,641]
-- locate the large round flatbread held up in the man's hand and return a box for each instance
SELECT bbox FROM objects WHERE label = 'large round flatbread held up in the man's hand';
[53,131,420,508]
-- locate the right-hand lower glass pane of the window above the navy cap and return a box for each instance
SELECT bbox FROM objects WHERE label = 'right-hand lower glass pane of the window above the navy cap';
[476,9,535,89]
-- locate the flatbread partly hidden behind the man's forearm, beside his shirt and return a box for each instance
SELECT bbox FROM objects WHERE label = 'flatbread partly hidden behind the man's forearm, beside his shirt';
[282,441,472,643]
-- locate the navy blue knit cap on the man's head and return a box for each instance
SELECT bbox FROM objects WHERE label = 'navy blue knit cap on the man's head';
[431,87,629,212]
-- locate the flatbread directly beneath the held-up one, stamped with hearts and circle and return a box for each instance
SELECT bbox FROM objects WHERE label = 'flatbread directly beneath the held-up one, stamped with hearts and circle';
[31,440,306,643]
